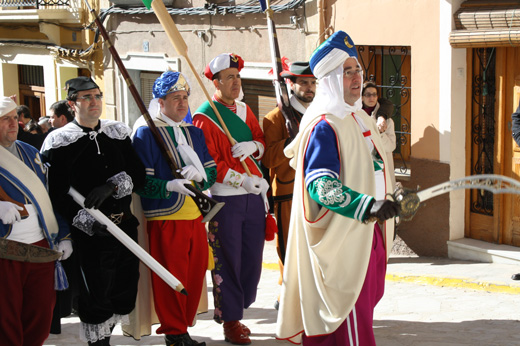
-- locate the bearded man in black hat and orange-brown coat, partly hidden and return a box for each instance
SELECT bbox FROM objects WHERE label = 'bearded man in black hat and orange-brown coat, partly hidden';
[262,61,316,308]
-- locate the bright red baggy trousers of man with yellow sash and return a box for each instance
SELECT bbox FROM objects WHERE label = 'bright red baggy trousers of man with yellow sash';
[147,216,208,335]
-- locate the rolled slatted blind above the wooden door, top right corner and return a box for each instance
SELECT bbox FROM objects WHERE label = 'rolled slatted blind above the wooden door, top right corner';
[450,0,520,48]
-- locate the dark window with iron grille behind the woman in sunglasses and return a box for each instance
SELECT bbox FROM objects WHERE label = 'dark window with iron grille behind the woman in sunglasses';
[357,45,412,173]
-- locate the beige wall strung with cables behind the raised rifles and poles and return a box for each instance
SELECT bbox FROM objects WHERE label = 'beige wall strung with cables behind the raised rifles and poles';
[108,5,317,109]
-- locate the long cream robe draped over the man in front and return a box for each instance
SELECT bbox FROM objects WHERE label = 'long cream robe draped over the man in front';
[277,110,393,343]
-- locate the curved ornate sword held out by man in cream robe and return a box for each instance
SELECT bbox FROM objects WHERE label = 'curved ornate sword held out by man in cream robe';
[390,174,520,221]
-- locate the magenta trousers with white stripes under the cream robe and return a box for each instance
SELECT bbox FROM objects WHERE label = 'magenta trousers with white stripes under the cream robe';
[302,223,386,346]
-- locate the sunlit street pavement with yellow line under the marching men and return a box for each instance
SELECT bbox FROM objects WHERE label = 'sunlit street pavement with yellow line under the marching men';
[44,242,520,346]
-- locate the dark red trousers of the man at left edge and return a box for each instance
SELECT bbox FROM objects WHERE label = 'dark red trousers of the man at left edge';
[0,239,56,346]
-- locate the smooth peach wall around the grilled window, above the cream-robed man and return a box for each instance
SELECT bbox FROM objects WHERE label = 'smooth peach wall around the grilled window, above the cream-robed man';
[328,0,440,160]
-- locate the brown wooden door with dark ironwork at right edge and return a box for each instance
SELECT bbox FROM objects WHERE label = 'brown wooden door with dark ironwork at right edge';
[465,48,520,246]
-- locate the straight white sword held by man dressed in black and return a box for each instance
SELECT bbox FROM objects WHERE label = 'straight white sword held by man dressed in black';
[69,187,188,295]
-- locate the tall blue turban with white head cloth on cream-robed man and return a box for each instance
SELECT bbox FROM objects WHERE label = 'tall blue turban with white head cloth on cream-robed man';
[302,31,363,123]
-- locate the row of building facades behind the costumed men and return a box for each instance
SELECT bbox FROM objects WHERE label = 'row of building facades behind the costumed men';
[0,0,520,260]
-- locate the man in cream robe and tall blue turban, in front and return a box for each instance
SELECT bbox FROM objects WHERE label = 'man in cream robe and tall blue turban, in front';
[277,31,399,346]
